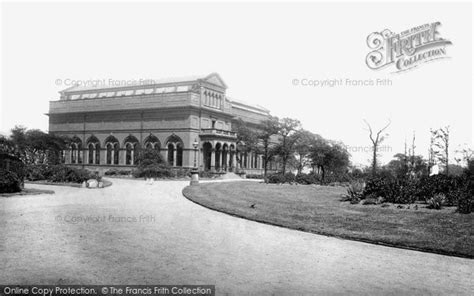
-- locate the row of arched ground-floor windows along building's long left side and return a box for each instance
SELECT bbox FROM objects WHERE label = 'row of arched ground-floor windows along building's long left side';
[70,135,183,166]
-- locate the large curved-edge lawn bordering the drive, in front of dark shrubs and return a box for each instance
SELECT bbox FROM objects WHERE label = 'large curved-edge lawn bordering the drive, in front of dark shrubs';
[183,182,474,258]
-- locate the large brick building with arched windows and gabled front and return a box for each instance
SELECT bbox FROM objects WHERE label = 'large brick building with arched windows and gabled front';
[48,73,273,173]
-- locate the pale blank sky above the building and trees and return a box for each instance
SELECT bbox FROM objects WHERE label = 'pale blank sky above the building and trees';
[0,1,474,165]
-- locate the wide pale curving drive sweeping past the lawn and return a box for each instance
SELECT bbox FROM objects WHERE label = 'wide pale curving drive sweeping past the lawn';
[0,180,474,295]
